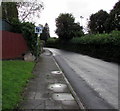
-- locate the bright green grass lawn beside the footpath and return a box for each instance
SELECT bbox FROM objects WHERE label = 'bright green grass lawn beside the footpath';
[2,60,35,110]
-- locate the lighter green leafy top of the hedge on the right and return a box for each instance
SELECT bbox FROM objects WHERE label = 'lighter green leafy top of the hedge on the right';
[70,31,120,46]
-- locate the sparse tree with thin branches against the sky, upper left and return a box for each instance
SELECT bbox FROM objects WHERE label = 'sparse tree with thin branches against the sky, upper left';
[17,0,43,22]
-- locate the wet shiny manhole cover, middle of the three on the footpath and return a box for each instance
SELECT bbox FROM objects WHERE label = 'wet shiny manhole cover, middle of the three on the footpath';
[48,83,67,92]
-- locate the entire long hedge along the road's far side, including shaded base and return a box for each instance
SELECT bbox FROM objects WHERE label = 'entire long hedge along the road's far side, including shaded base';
[46,31,120,62]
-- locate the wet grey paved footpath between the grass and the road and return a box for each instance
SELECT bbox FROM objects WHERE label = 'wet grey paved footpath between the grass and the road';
[19,50,80,111]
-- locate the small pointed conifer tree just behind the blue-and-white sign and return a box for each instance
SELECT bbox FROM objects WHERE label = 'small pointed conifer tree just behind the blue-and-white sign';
[40,23,50,42]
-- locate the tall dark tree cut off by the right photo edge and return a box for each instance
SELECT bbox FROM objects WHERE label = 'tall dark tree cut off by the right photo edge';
[105,1,120,32]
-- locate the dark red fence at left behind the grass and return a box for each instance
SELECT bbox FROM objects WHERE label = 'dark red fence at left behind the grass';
[0,31,28,59]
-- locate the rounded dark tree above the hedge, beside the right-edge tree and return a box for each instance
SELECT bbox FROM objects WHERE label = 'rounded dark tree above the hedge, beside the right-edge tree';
[88,10,109,33]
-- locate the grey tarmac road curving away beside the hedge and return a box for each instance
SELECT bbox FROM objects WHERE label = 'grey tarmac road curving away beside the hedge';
[47,48,118,109]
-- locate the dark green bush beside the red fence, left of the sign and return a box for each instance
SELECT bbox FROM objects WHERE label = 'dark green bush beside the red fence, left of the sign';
[12,20,40,56]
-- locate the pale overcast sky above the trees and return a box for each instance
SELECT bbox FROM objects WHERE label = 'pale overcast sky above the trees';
[36,0,118,37]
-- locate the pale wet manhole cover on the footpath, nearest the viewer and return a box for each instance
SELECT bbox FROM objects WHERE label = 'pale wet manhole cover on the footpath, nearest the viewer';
[52,93,74,101]
